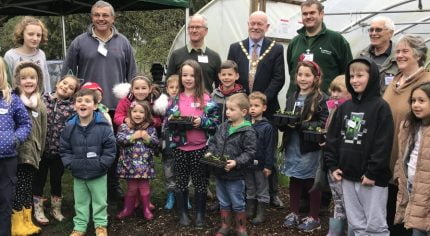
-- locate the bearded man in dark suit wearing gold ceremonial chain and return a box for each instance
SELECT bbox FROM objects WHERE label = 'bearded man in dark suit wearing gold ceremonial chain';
[227,11,285,208]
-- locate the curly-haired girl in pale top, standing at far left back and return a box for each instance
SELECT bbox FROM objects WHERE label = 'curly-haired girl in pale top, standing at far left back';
[4,16,51,93]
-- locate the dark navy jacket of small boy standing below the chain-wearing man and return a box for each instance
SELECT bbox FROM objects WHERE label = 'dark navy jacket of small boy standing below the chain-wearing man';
[250,118,278,170]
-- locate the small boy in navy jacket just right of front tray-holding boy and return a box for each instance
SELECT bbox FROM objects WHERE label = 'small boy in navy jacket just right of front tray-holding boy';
[245,92,278,224]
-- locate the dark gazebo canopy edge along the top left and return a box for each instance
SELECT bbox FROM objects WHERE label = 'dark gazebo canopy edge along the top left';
[0,0,190,16]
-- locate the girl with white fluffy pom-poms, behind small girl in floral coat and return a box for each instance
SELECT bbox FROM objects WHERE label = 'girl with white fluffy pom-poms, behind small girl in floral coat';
[113,75,161,128]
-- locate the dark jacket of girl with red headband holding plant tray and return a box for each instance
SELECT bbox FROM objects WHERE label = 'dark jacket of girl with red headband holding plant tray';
[281,92,329,154]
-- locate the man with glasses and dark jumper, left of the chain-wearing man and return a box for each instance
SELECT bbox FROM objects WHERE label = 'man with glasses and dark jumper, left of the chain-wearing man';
[166,14,221,93]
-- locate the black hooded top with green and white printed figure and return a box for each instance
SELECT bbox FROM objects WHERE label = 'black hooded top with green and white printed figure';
[324,57,394,187]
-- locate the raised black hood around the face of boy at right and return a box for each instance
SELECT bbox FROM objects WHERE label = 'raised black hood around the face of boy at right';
[345,57,381,103]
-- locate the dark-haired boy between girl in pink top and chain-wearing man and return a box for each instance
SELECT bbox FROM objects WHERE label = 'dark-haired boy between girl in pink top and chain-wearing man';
[212,60,246,123]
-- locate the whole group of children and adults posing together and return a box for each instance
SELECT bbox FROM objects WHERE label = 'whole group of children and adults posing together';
[0,0,430,236]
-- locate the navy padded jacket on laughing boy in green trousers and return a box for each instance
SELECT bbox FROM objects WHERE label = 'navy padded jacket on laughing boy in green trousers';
[60,112,116,179]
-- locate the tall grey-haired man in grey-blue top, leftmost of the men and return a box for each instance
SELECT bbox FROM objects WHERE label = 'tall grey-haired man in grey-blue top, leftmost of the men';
[61,1,136,200]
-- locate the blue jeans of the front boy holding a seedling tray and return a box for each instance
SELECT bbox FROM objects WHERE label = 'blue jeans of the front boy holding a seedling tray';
[216,178,245,212]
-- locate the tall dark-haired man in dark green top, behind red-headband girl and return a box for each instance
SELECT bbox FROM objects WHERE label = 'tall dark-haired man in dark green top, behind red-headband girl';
[287,0,352,95]
